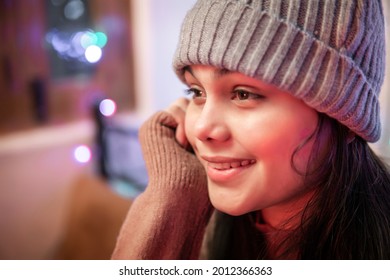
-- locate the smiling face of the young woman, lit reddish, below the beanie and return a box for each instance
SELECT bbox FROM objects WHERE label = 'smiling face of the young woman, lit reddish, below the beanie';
[185,65,318,224]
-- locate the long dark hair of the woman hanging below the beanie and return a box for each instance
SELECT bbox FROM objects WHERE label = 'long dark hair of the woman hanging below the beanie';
[208,114,390,259]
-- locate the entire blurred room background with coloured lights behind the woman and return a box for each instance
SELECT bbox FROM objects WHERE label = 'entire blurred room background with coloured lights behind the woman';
[0,0,390,259]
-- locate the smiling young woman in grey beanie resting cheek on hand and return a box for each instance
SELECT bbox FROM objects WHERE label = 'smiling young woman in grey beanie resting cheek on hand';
[113,0,390,259]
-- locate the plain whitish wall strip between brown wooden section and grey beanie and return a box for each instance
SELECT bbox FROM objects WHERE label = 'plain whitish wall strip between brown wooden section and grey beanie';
[132,0,195,118]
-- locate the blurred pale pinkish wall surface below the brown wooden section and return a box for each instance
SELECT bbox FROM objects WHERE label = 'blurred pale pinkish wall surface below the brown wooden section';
[0,122,94,259]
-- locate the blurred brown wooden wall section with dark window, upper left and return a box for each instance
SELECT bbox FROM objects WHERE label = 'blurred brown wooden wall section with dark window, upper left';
[0,0,136,134]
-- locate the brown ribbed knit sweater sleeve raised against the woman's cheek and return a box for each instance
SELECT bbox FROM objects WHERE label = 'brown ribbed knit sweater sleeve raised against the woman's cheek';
[112,112,212,259]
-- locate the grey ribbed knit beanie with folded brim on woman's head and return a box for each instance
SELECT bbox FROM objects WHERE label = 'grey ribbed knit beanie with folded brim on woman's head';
[173,0,385,142]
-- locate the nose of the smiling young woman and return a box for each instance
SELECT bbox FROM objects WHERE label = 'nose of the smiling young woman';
[194,100,230,142]
